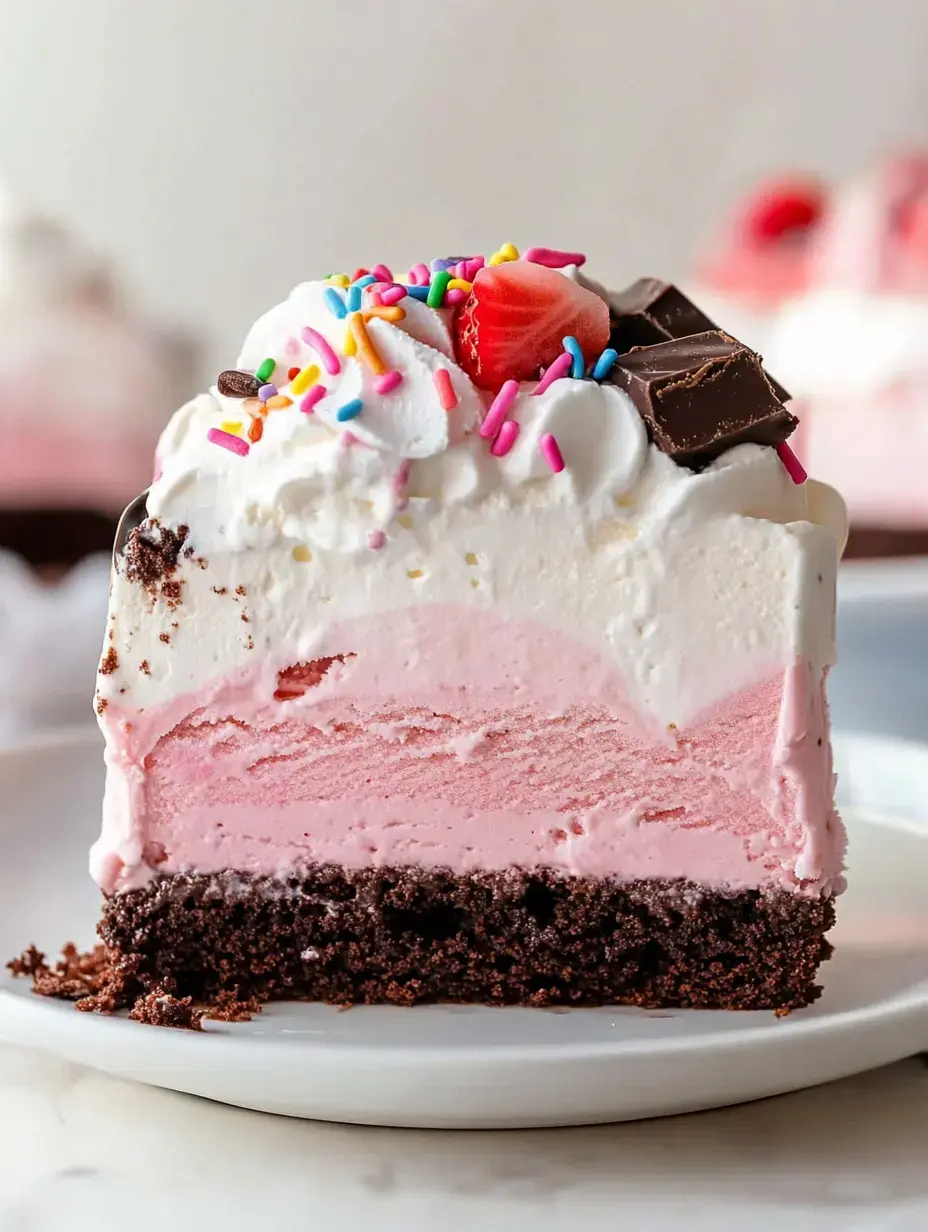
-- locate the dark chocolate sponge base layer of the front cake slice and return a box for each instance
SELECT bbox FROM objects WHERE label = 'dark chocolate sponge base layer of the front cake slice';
[97,865,834,1011]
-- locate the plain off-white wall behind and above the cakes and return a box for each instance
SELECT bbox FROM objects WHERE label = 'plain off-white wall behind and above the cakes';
[0,0,928,371]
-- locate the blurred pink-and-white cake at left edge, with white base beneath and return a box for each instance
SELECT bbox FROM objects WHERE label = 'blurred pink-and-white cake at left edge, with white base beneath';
[0,182,195,743]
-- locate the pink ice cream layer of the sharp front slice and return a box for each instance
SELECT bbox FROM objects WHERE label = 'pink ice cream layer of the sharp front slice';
[94,607,843,893]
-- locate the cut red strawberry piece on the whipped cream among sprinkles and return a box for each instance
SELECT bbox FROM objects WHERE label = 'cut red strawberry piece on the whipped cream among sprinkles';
[455,261,609,389]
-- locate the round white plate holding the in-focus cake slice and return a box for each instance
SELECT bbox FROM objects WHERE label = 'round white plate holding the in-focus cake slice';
[0,733,928,1127]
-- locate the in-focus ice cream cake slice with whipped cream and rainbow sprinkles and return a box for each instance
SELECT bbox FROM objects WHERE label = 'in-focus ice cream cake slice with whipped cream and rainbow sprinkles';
[91,249,843,1010]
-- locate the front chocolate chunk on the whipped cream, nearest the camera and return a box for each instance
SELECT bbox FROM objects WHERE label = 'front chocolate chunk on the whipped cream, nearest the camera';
[610,329,799,469]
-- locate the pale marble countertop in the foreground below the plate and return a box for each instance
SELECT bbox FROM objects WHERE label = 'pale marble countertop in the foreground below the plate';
[0,1046,928,1232]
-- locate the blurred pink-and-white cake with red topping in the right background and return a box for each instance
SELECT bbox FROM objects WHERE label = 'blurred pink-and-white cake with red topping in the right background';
[696,155,928,557]
